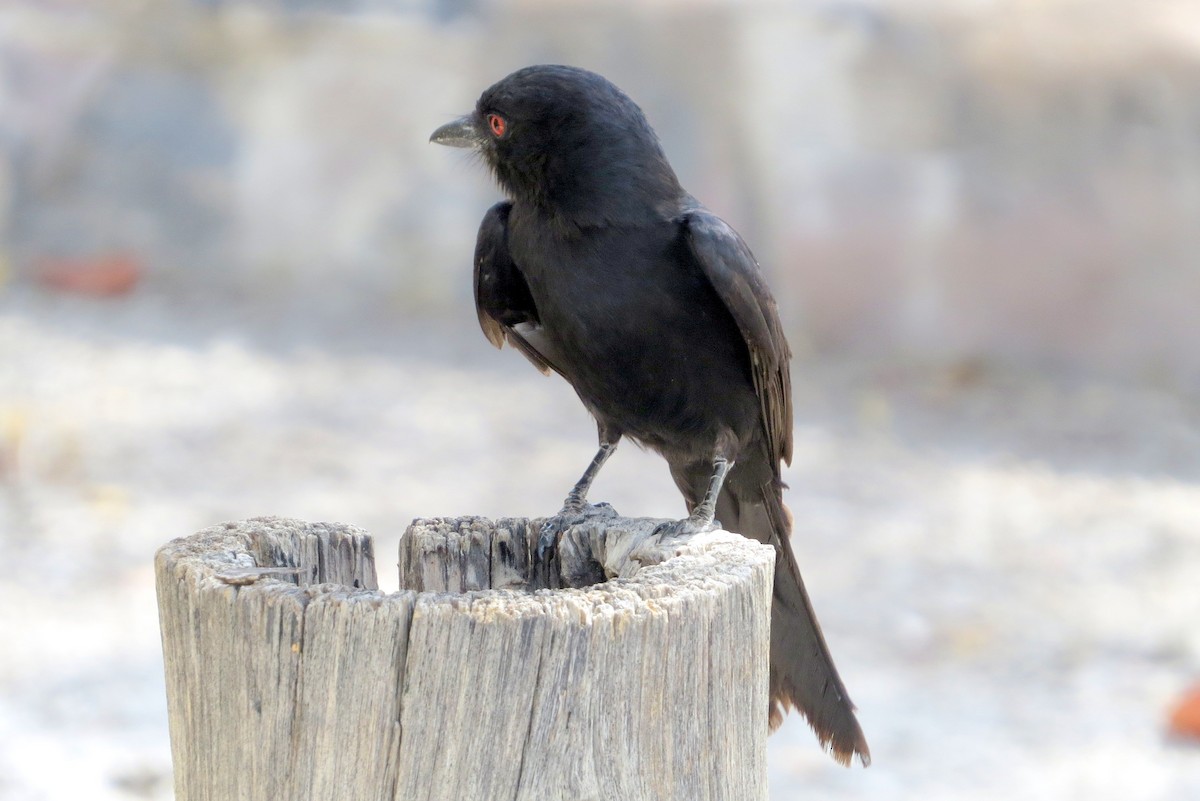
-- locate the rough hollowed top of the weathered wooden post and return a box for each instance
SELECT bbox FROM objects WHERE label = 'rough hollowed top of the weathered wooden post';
[156,513,774,600]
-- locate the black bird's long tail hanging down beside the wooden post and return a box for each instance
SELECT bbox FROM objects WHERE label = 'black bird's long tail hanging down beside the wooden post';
[716,476,871,766]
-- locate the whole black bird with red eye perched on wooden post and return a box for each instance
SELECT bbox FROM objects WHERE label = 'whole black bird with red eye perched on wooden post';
[430,66,870,765]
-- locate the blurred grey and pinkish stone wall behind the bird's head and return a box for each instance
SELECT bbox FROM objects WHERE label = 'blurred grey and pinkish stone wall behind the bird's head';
[0,0,1200,381]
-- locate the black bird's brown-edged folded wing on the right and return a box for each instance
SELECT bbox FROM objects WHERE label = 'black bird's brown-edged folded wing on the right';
[680,209,792,464]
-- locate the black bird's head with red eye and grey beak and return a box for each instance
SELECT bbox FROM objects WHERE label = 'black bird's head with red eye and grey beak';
[430,66,684,225]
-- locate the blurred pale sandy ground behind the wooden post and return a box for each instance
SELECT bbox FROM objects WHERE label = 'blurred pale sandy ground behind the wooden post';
[0,289,1200,801]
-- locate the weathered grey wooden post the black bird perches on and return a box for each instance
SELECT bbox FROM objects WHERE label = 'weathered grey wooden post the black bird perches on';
[155,516,774,801]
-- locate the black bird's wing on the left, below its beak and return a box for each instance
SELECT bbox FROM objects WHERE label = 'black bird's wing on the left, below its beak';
[475,201,560,375]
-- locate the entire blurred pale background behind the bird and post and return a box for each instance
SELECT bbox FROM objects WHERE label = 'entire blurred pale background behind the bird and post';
[0,0,1200,801]
